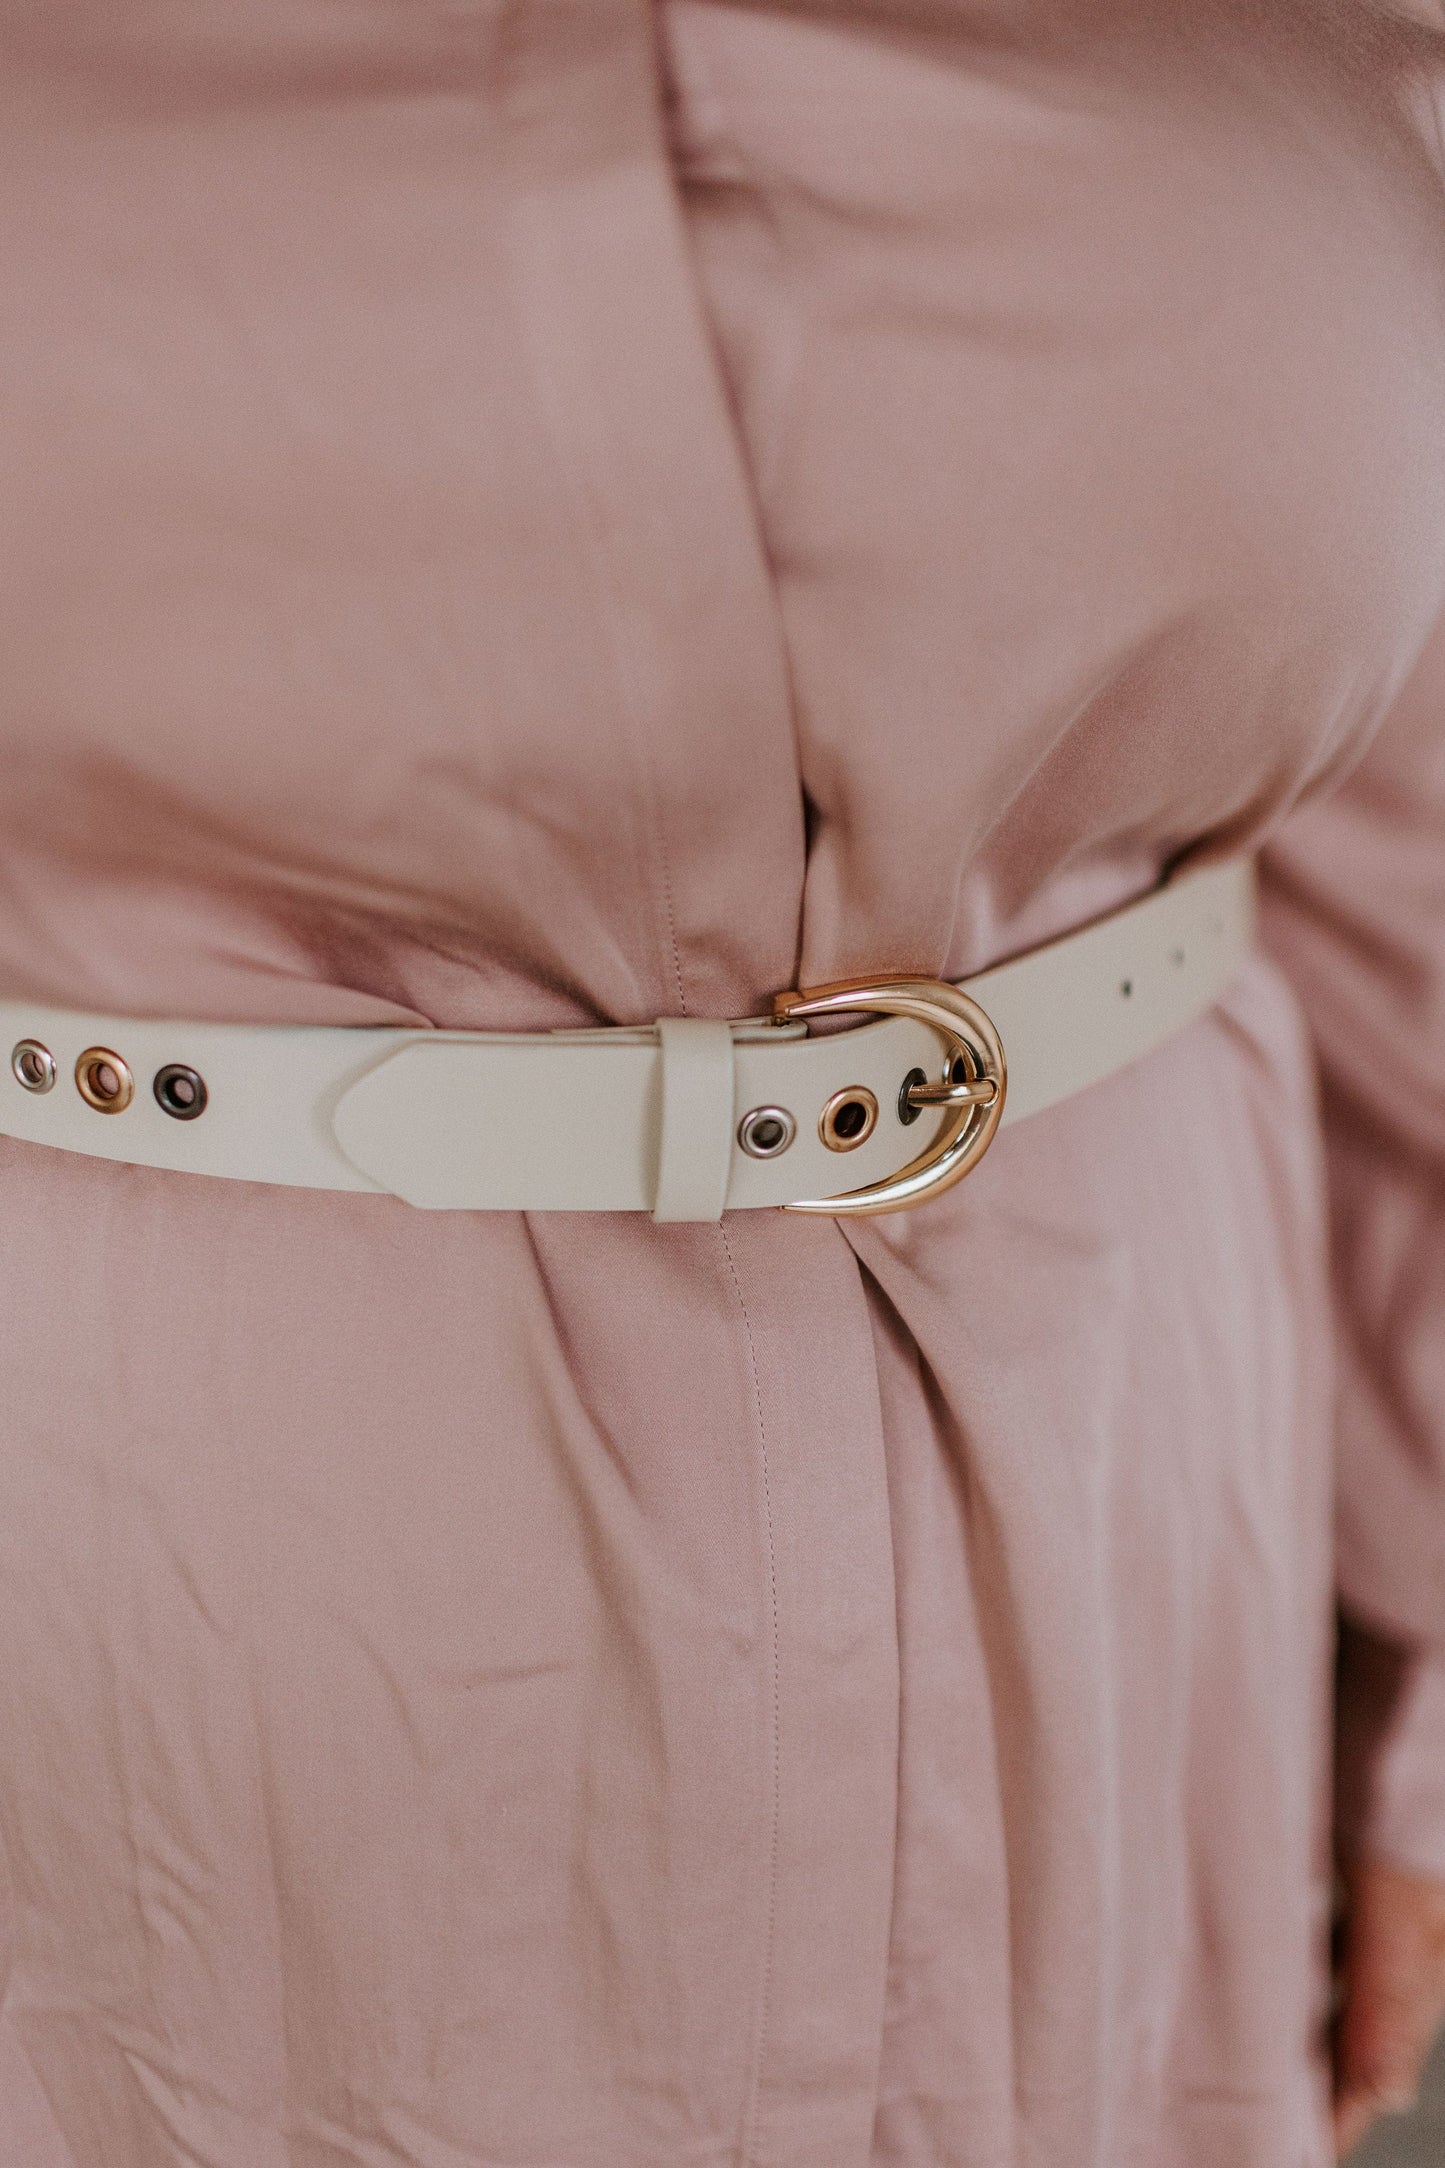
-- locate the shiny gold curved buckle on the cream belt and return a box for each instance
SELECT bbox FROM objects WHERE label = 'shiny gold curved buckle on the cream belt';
[773,978,1007,1218]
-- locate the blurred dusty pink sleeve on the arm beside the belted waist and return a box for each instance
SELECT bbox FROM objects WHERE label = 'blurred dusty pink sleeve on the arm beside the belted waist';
[1265,624,1445,1880]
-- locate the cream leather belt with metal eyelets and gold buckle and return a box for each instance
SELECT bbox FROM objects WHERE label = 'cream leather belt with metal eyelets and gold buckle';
[0,861,1254,1221]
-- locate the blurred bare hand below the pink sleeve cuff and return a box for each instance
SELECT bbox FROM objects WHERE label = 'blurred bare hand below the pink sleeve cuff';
[1335,1860,1445,2159]
